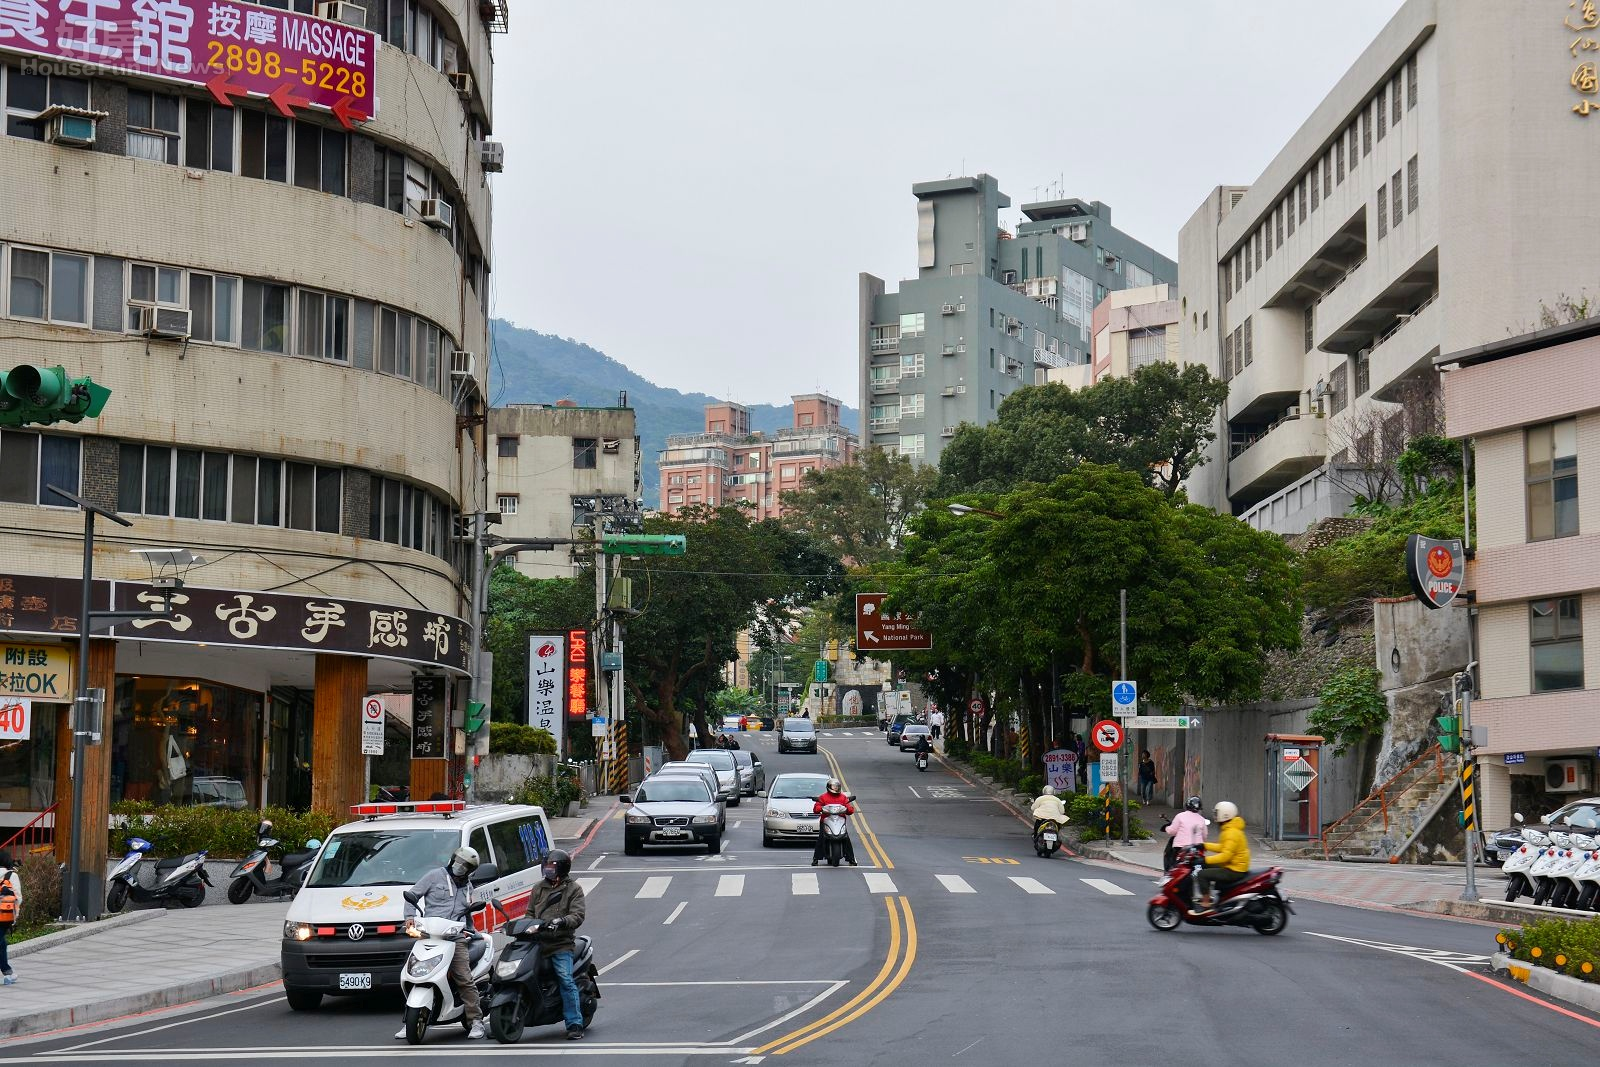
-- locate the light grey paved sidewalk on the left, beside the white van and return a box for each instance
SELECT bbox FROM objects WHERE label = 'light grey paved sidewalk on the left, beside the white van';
[0,809,610,1038]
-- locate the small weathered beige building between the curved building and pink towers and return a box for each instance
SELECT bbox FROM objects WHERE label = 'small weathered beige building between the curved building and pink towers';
[488,400,645,577]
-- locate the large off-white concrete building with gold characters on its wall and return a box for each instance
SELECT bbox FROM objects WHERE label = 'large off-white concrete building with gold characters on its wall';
[1179,0,1600,533]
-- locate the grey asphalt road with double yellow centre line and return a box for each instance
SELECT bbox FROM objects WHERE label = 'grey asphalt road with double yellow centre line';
[0,729,1600,1067]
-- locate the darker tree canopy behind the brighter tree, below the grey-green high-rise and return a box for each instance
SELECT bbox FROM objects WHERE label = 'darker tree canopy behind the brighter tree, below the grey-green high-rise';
[934,362,1227,496]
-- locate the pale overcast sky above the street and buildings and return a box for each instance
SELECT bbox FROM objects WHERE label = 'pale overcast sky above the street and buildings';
[493,0,1400,403]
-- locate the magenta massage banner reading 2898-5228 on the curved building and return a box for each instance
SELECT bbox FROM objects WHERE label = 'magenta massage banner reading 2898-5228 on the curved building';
[0,0,378,126]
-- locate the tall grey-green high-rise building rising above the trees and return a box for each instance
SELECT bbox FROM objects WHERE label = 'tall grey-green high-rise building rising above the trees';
[859,174,1178,464]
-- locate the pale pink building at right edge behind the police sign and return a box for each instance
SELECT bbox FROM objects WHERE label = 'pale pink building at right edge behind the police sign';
[1438,318,1600,829]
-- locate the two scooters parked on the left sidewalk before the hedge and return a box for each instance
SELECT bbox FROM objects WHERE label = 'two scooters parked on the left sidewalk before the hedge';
[106,819,322,913]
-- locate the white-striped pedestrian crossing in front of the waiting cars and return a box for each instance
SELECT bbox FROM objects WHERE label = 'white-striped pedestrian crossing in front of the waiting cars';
[578,869,1134,901]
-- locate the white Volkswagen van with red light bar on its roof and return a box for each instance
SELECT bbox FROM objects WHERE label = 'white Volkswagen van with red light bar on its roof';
[283,800,554,1011]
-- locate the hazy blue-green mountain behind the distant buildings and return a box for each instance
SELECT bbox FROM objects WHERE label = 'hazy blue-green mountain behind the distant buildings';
[490,318,861,506]
